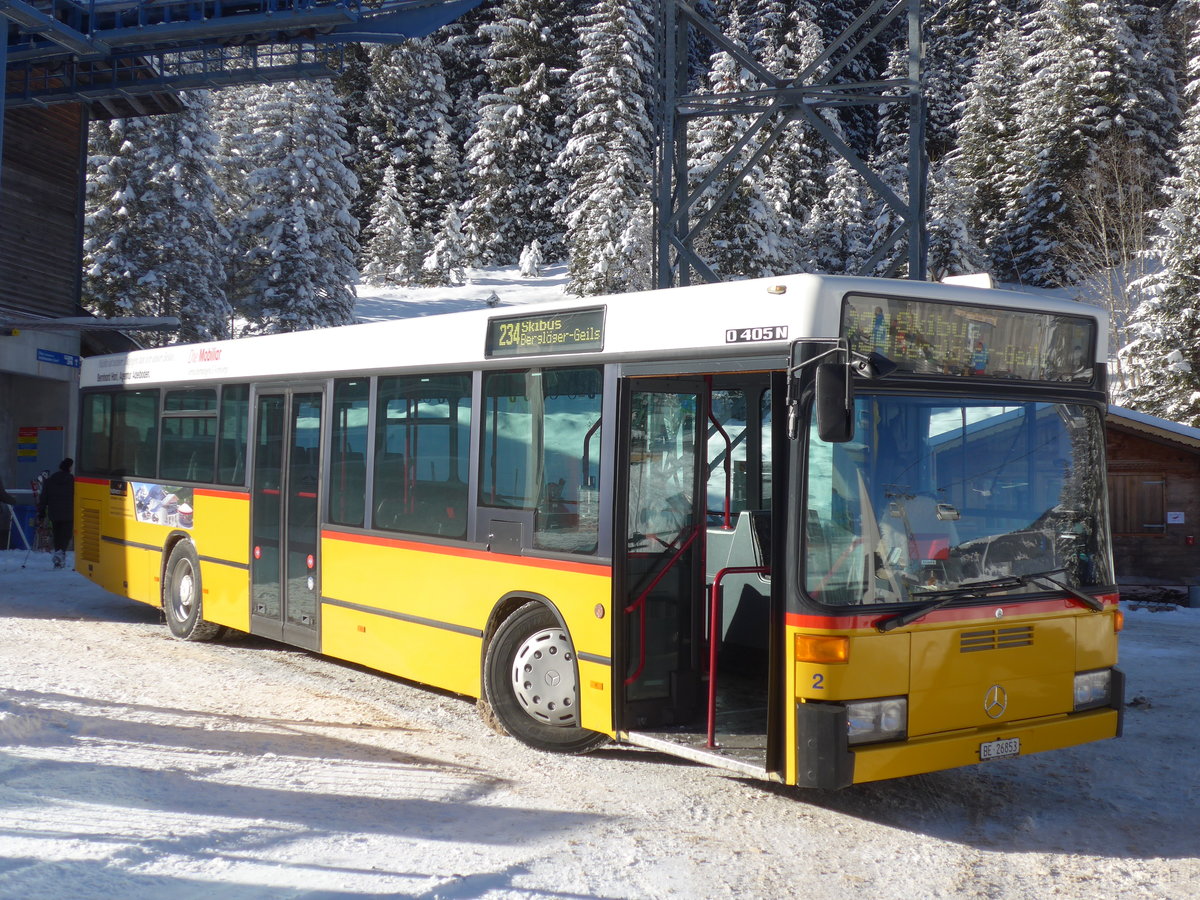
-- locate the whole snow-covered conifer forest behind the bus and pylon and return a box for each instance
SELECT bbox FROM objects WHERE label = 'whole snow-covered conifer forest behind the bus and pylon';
[83,0,1200,426]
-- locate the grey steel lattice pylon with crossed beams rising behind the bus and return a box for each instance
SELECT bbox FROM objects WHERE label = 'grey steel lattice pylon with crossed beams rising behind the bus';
[654,0,928,288]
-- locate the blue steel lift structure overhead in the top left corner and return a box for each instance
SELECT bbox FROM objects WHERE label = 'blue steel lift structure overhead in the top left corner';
[0,0,481,164]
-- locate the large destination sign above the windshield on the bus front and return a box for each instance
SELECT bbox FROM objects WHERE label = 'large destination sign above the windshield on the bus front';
[842,294,1096,384]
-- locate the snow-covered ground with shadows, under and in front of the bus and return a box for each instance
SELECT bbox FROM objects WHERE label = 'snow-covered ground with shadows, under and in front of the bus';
[0,551,1200,900]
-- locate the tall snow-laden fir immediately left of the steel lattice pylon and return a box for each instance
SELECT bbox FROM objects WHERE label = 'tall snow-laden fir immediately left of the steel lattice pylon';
[558,0,655,295]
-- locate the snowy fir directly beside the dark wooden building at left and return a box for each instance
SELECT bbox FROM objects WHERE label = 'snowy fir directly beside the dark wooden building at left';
[83,91,230,344]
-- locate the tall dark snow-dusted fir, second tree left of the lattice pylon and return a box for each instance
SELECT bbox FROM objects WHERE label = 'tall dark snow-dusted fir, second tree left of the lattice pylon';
[464,0,577,264]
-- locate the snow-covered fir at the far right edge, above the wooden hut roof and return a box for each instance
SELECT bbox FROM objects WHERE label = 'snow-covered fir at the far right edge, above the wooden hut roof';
[1121,11,1200,427]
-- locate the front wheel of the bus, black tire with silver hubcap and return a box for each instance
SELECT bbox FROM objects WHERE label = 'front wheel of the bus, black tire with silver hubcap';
[484,602,605,754]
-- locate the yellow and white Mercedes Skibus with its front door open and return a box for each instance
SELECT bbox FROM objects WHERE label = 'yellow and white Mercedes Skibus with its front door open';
[76,275,1124,788]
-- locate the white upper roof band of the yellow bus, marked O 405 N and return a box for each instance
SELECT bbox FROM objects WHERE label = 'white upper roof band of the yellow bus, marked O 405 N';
[80,275,1108,388]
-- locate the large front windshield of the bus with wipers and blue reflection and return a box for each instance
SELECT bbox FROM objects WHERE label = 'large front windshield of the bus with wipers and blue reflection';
[802,396,1112,606]
